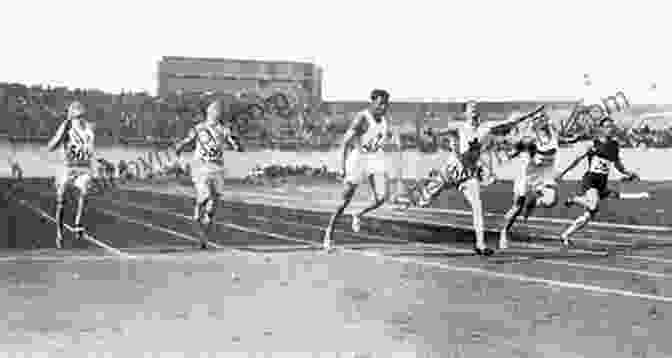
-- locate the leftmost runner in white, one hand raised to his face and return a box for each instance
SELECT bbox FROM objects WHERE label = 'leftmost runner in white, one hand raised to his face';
[47,101,95,248]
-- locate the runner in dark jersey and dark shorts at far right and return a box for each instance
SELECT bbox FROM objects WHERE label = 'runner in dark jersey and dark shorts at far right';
[558,117,639,246]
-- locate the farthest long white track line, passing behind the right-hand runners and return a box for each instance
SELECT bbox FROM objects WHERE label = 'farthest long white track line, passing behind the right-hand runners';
[219,189,672,233]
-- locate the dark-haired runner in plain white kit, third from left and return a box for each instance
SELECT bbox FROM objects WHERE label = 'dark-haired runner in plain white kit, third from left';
[323,89,400,250]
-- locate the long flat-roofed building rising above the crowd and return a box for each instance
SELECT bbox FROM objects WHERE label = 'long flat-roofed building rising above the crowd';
[158,56,322,104]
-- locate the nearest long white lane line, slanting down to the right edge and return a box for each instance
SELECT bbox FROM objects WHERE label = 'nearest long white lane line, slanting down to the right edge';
[101,196,672,303]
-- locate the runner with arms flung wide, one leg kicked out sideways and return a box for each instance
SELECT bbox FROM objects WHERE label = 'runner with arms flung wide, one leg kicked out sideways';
[396,101,543,256]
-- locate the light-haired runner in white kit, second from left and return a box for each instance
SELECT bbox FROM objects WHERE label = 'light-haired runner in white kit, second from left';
[175,100,240,250]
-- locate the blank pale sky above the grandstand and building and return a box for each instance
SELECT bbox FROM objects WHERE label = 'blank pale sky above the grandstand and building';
[0,0,672,103]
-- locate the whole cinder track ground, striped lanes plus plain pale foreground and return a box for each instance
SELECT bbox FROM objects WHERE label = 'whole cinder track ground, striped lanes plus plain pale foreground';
[0,181,672,357]
